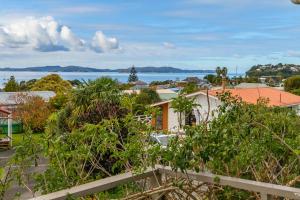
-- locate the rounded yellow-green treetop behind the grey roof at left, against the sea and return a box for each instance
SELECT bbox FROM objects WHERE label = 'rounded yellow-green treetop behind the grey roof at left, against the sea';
[31,74,72,94]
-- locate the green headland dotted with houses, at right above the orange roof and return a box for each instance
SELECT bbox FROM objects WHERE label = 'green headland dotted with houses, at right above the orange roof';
[246,63,300,78]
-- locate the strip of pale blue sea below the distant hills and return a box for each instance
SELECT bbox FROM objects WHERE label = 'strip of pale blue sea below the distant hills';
[0,71,243,87]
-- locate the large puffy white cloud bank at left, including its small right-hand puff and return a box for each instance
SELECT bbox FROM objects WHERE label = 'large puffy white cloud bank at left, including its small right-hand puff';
[0,16,119,53]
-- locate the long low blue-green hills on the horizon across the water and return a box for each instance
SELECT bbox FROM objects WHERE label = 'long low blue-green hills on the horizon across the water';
[0,66,215,73]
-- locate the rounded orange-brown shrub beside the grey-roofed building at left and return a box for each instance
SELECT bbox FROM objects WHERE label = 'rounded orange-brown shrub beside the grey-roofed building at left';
[14,94,51,132]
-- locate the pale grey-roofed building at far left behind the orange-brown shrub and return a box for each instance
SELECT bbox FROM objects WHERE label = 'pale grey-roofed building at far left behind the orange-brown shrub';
[0,91,55,110]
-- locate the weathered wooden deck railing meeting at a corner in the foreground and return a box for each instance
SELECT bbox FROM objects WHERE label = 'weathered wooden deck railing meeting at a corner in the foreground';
[32,166,300,200]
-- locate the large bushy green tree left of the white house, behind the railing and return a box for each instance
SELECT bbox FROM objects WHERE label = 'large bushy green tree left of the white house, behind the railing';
[30,78,150,193]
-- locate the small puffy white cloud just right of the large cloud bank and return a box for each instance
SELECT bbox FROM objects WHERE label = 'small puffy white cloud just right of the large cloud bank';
[91,31,119,53]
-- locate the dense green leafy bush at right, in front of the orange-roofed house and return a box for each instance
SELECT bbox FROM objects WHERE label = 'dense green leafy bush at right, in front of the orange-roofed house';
[162,93,300,199]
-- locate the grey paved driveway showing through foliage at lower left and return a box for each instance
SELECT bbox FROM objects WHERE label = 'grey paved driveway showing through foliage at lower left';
[0,149,47,200]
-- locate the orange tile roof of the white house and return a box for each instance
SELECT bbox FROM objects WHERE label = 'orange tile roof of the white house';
[209,87,300,106]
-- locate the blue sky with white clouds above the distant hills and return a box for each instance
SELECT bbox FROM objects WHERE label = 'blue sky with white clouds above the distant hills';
[0,0,300,72]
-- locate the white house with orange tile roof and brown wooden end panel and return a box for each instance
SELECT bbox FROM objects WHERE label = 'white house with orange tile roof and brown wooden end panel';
[152,87,300,131]
